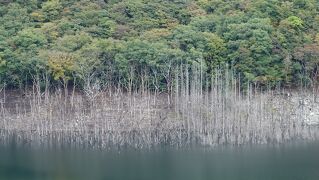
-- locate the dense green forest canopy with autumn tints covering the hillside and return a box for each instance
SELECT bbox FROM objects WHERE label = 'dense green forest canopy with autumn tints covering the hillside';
[0,0,319,90]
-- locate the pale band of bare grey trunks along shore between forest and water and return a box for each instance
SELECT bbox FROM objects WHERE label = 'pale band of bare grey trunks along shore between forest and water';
[0,86,319,149]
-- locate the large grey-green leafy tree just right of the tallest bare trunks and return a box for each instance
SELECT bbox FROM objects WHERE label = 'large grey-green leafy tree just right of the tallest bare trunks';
[224,19,282,84]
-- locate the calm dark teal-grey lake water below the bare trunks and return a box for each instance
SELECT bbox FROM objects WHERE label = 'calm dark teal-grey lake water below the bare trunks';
[0,143,319,180]
